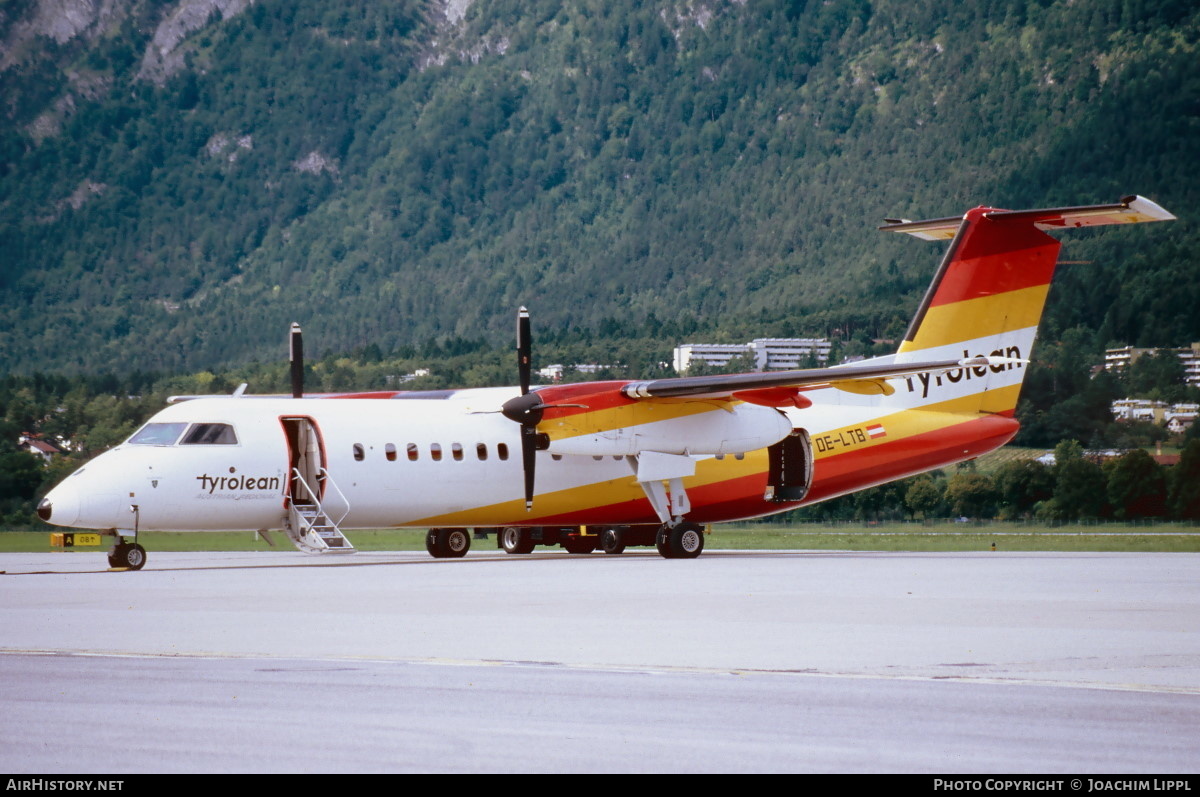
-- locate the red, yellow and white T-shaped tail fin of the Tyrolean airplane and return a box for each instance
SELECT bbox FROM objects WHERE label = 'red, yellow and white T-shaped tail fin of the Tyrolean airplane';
[880,197,1175,415]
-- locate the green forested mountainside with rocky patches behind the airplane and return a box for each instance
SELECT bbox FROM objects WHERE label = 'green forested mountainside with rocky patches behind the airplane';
[0,0,1200,373]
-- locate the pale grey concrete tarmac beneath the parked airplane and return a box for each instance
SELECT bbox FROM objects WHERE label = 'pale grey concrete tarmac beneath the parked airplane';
[0,549,1200,773]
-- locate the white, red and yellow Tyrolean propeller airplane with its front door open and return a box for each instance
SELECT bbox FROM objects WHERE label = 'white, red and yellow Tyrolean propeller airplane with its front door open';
[37,196,1175,570]
